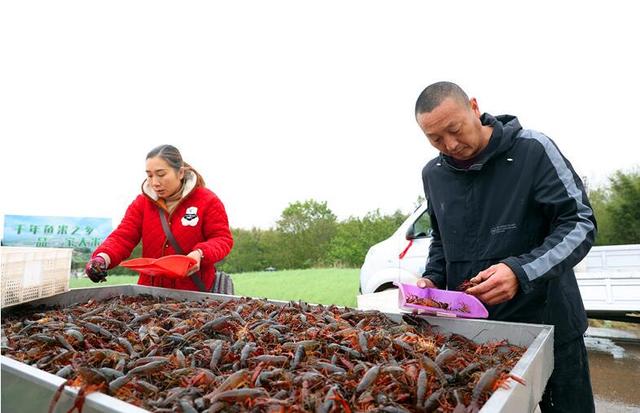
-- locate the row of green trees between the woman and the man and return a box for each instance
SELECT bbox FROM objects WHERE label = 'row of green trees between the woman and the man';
[217,199,408,273]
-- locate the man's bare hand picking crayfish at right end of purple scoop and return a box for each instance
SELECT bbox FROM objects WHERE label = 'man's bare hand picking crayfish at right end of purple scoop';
[465,263,518,305]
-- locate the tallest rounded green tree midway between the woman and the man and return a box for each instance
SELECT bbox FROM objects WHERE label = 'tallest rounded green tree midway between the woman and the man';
[276,199,336,268]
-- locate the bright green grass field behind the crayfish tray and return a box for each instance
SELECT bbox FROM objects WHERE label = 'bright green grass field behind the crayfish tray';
[70,268,360,307]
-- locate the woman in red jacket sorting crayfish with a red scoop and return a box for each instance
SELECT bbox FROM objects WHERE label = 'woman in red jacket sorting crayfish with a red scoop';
[85,145,233,291]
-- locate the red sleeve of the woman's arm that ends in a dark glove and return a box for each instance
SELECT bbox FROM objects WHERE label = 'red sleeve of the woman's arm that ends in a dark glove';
[93,195,146,268]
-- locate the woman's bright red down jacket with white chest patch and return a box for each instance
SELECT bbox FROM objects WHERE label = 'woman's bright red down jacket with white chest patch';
[93,179,233,291]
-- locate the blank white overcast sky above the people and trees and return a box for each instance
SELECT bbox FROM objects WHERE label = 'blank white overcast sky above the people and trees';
[0,0,640,235]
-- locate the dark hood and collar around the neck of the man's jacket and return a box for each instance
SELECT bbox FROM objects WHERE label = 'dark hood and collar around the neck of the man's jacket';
[440,113,522,171]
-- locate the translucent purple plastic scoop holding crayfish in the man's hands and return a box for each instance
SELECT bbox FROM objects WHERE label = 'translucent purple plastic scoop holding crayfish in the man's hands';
[394,283,489,318]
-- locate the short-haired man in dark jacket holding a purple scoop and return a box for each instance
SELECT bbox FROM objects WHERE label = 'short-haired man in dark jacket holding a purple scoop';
[415,82,596,412]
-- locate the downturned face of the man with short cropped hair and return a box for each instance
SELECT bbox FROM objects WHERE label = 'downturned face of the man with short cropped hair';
[417,98,491,161]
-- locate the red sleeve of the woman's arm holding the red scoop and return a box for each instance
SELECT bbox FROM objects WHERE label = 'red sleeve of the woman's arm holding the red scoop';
[193,195,238,265]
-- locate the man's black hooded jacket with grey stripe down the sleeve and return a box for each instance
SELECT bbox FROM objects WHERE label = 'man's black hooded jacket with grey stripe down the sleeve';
[422,114,596,344]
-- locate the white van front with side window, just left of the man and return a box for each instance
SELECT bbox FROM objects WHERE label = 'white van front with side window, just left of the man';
[360,202,431,294]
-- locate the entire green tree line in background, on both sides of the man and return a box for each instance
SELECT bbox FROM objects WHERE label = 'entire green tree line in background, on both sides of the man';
[218,167,640,273]
